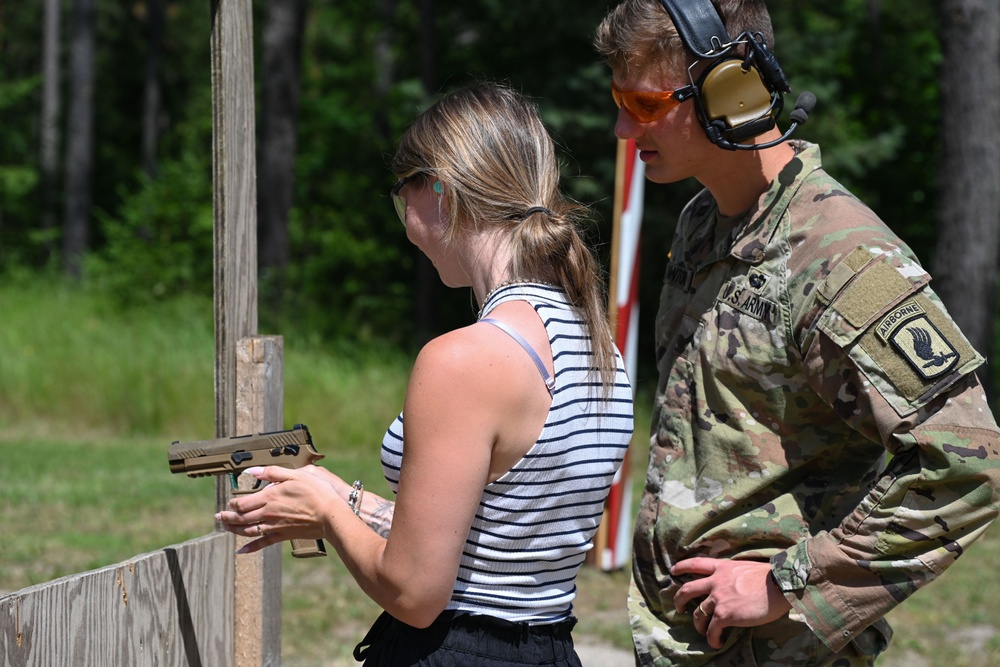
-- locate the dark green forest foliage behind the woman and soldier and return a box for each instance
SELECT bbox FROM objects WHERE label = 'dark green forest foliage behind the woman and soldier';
[0,0,964,373]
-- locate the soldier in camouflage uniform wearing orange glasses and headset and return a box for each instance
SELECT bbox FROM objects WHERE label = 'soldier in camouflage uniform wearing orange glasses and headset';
[595,0,1000,666]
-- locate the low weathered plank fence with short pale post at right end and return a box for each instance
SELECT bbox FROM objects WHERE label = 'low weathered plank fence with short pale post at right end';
[0,336,287,667]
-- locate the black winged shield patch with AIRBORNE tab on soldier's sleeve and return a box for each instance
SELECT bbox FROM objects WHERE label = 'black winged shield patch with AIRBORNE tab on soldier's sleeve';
[875,301,959,380]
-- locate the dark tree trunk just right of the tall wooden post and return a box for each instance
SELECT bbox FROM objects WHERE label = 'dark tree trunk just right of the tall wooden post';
[257,0,306,280]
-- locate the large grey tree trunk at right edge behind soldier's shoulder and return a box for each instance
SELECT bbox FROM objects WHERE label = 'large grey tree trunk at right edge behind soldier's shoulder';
[932,0,1000,400]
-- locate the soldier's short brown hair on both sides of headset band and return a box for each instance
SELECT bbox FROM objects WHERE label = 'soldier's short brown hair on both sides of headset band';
[594,0,774,76]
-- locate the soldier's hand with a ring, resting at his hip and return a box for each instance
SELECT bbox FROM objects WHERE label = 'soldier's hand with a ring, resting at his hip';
[670,558,792,648]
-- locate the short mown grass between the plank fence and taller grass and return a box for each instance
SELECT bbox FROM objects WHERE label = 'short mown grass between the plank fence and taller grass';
[0,436,215,592]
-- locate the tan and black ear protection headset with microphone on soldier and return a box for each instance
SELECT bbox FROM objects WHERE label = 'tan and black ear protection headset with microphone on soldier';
[661,0,816,151]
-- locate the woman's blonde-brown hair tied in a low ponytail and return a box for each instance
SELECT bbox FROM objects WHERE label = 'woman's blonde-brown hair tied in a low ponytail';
[392,82,616,392]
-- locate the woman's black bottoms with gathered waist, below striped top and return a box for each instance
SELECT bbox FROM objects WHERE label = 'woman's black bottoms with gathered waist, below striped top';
[354,611,582,667]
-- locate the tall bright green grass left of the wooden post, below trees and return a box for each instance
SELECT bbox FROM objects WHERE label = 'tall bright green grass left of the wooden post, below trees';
[0,277,214,437]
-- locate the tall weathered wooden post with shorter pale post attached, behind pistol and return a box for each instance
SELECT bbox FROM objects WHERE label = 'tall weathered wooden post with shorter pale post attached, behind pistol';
[211,0,282,667]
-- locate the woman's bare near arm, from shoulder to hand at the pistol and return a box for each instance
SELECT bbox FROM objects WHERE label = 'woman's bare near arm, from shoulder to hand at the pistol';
[219,327,516,627]
